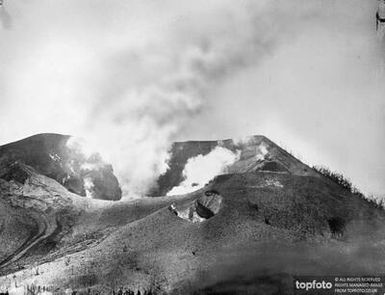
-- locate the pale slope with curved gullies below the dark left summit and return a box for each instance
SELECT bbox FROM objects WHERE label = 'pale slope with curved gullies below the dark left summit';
[0,164,78,269]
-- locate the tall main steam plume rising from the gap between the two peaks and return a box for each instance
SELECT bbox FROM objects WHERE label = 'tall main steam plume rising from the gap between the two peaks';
[69,2,318,199]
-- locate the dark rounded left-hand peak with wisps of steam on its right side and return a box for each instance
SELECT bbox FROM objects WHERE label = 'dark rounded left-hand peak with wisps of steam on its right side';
[0,134,122,200]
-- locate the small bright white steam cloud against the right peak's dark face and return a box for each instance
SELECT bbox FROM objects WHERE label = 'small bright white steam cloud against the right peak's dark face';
[167,146,240,196]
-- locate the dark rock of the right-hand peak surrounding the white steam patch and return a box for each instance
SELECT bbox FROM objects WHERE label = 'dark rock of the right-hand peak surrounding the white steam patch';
[149,135,320,197]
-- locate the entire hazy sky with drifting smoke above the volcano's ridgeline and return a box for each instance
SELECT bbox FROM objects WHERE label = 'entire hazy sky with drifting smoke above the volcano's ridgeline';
[0,0,385,199]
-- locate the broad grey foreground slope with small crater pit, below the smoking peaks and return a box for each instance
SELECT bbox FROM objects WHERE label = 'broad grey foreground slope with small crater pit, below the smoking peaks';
[0,137,385,294]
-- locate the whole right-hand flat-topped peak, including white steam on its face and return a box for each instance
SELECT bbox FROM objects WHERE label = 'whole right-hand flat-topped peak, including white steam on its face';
[150,135,320,196]
